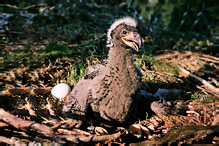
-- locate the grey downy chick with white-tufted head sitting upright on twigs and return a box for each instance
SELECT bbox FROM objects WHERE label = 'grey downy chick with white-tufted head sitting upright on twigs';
[63,17,141,126]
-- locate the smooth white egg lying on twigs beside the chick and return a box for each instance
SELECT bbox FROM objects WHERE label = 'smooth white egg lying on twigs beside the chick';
[51,83,71,100]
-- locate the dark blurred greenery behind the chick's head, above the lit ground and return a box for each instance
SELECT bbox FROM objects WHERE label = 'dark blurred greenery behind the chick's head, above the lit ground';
[0,0,219,53]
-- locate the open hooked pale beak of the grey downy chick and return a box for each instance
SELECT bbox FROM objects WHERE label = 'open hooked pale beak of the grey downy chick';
[122,32,141,52]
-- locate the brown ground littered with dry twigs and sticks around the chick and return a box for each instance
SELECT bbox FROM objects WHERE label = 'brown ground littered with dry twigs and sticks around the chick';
[0,45,219,144]
